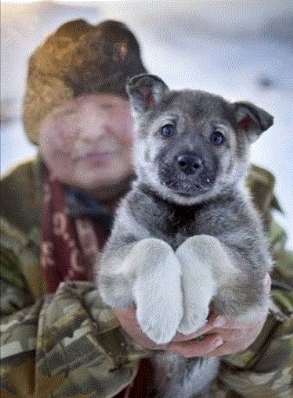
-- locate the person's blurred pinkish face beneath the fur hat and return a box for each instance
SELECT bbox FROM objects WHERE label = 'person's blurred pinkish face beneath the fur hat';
[40,94,133,190]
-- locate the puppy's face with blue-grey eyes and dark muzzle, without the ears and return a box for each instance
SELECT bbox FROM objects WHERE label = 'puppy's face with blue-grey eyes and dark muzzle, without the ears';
[134,92,237,204]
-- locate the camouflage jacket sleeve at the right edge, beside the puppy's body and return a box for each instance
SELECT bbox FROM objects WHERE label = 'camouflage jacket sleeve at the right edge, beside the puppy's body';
[213,223,293,398]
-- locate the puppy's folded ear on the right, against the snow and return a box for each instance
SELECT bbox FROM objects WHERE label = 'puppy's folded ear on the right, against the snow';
[234,102,274,142]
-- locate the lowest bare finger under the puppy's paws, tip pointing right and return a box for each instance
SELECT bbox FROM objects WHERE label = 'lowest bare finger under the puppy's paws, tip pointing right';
[167,334,223,358]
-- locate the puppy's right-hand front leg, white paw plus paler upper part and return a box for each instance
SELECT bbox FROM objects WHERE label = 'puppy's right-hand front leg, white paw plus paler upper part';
[176,235,236,334]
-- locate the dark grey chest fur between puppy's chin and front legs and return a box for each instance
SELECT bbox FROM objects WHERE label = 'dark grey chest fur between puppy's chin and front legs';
[127,186,244,250]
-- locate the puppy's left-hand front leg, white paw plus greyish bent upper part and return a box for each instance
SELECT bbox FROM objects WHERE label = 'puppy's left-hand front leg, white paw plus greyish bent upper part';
[97,238,183,344]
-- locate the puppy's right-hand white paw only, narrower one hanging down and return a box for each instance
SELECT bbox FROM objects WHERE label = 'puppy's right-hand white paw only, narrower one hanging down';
[176,237,217,335]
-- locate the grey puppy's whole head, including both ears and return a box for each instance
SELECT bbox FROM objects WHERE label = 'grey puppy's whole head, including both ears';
[126,74,273,205]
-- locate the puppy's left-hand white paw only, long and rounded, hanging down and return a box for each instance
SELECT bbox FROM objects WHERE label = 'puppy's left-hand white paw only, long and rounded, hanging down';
[132,239,183,344]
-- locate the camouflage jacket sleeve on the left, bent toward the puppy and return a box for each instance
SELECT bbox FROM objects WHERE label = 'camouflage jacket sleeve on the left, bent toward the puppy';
[0,222,147,398]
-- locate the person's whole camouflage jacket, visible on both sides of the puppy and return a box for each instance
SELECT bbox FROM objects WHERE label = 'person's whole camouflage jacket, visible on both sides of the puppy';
[0,161,293,398]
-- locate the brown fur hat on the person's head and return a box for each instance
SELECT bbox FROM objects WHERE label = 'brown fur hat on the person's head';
[23,19,146,144]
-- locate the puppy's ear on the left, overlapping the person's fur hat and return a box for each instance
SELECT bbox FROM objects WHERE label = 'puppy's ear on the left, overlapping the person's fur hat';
[126,73,169,112]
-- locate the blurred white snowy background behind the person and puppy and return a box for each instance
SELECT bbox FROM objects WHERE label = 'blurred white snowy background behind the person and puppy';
[1,0,293,249]
